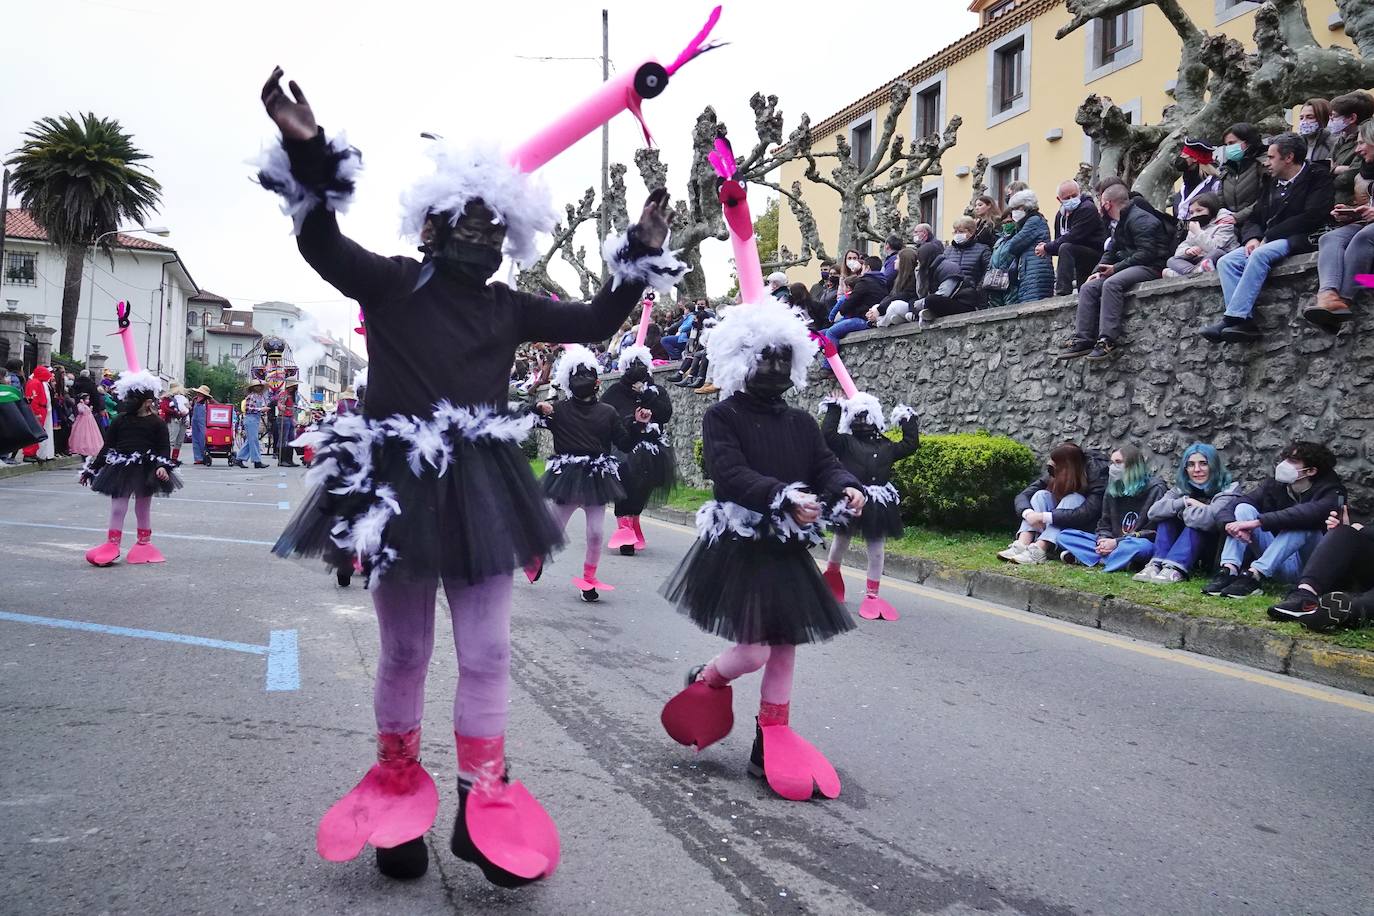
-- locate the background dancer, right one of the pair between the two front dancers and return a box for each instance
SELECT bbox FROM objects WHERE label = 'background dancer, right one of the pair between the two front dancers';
[602,346,676,556]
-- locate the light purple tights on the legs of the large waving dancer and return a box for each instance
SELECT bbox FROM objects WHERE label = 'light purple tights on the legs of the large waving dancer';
[372,573,513,737]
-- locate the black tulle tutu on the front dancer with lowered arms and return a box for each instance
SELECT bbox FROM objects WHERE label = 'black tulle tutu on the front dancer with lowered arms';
[658,533,855,645]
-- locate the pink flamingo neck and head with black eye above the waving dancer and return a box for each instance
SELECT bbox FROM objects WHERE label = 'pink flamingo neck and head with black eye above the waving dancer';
[510,7,720,172]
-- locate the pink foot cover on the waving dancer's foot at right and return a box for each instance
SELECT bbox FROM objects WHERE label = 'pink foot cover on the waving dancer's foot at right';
[463,781,559,880]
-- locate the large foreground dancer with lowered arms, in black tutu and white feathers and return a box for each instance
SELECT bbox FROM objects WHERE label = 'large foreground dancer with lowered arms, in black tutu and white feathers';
[660,302,867,801]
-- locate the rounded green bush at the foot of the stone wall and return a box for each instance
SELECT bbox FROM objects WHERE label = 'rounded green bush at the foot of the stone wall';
[892,431,1039,530]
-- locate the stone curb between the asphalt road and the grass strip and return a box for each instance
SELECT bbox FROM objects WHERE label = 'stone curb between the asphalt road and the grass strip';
[644,508,1374,696]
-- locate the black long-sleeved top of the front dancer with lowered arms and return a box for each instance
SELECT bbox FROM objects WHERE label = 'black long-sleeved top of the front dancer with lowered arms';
[702,391,861,515]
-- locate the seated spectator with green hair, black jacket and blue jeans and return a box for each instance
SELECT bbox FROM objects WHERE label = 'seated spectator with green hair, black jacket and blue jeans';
[1059,445,1165,573]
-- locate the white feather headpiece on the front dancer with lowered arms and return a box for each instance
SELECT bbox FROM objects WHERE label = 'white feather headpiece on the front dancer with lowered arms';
[706,299,816,398]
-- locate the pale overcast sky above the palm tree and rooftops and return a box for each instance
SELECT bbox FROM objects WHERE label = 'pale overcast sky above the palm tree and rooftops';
[0,0,977,343]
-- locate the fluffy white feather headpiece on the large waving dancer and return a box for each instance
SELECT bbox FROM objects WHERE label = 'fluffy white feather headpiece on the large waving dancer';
[401,140,558,266]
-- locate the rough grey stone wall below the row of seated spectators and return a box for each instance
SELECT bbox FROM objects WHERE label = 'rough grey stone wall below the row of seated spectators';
[626,255,1374,515]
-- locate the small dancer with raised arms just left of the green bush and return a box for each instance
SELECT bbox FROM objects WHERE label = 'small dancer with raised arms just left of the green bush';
[820,391,921,621]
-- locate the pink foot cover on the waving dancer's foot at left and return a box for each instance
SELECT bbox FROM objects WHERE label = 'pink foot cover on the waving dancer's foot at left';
[315,761,438,862]
